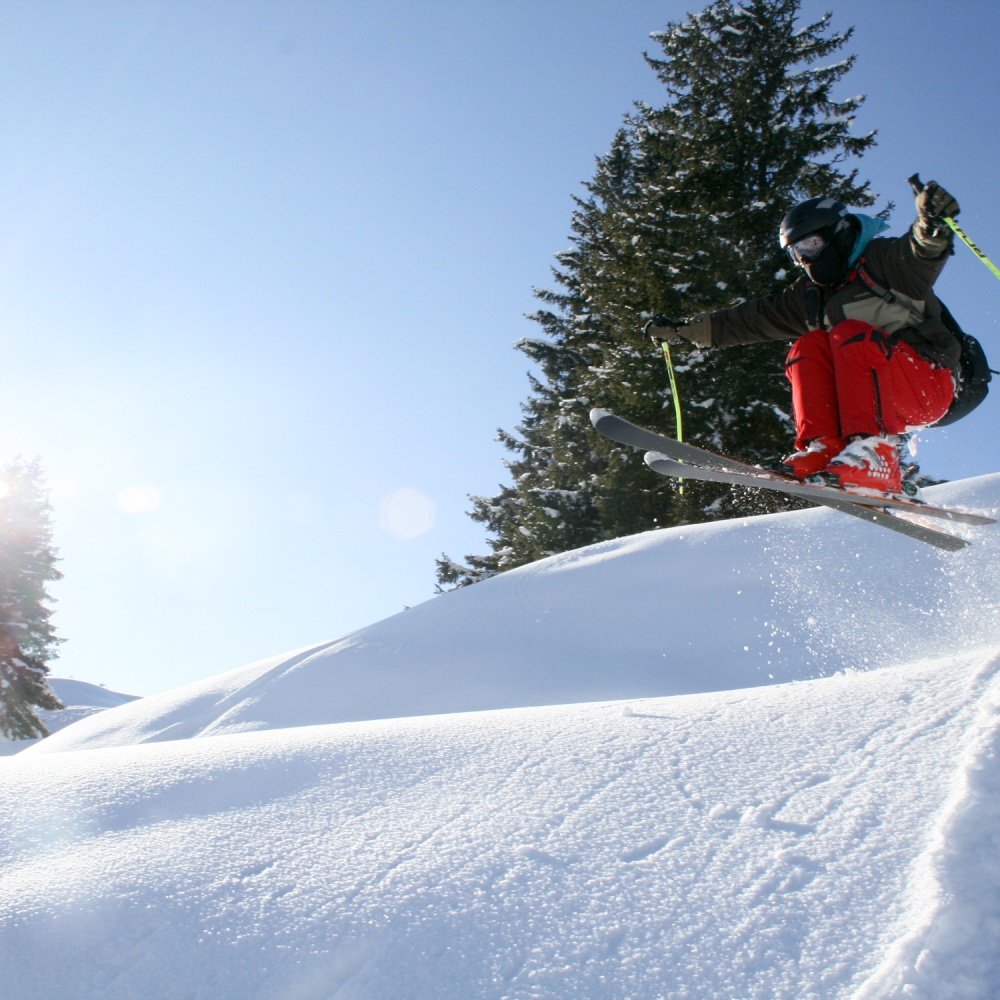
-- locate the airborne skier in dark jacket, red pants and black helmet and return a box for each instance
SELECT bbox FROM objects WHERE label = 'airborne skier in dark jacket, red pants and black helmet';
[645,181,961,493]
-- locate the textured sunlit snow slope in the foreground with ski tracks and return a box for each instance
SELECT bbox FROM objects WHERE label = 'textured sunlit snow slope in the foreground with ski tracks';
[0,649,1000,1000]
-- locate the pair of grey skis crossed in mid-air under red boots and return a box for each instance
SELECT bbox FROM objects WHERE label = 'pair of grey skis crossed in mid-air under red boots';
[590,409,996,552]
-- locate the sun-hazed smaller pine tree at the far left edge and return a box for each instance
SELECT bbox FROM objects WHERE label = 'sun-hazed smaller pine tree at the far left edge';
[0,460,63,740]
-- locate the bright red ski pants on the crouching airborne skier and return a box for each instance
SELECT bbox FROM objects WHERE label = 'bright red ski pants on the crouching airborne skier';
[785,319,955,448]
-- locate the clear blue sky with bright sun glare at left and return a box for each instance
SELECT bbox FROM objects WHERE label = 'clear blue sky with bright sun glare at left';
[0,0,1000,694]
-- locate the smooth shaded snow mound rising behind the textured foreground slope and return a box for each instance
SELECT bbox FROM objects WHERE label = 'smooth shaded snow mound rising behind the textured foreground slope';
[26,474,1000,754]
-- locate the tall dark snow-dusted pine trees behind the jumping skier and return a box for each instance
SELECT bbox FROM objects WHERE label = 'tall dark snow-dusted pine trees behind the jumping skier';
[438,0,875,587]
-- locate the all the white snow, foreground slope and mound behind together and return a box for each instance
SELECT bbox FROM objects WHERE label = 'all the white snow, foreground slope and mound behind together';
[0,475,1000,1000]
